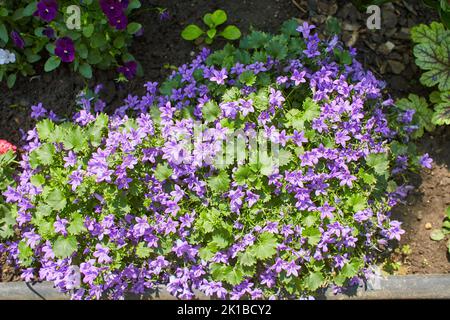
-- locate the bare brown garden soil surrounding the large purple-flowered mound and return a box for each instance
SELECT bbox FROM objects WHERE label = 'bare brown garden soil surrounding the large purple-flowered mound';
[0,0,450,296]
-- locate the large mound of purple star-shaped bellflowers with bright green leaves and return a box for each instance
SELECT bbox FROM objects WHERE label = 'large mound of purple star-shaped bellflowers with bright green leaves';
[1,20,431,299]
